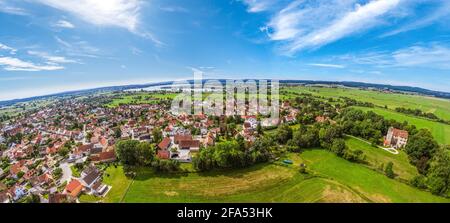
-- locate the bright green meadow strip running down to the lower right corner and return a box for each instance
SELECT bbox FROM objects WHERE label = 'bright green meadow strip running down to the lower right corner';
[300,149,450,203]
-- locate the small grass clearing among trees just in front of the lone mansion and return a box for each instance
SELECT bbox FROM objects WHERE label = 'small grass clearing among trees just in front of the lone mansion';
[345,137,418,180]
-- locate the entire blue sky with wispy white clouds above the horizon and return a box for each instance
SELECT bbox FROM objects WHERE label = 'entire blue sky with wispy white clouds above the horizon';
[0,0,450,100]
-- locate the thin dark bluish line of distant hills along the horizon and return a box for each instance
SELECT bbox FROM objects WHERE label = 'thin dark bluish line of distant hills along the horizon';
[0,79,450,107]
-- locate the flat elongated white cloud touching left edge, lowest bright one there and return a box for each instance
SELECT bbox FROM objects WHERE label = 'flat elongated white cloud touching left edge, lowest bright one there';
[0,57,64,71]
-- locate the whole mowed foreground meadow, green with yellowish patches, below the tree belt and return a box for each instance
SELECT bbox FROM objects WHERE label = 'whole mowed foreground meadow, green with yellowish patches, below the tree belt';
[93,149,449,203]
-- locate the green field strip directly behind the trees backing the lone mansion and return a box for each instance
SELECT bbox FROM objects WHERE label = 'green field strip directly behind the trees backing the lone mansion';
[356,107,450,145]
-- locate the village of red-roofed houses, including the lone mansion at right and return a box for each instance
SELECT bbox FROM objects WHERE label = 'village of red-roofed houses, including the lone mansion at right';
[0,91,408,203]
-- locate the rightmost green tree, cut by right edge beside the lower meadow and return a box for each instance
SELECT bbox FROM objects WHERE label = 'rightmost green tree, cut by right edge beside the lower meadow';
[427,148,450,195]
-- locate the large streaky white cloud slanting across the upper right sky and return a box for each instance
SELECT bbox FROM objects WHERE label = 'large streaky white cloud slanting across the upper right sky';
[261,0,405,54]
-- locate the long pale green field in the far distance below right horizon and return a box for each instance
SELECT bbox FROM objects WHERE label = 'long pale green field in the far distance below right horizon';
[282,87,450,120]
